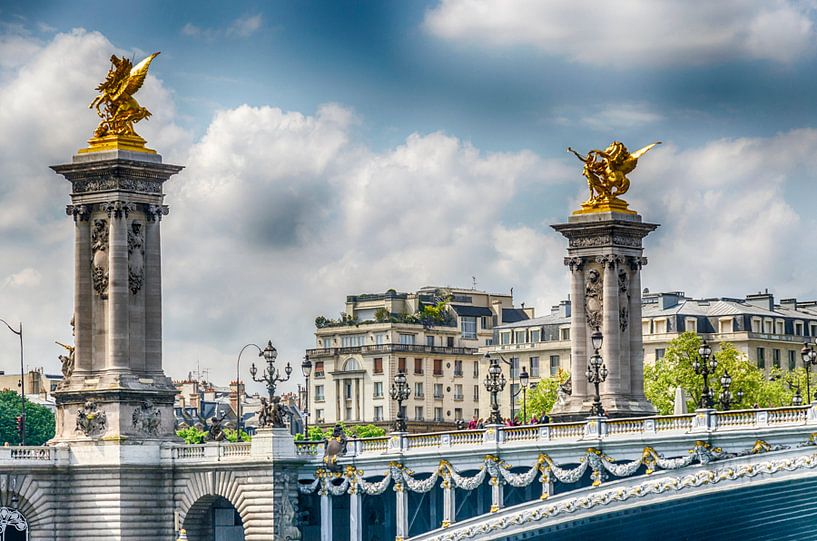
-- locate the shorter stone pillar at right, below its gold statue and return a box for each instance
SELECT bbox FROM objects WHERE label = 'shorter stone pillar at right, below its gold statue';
[552,211,658,421]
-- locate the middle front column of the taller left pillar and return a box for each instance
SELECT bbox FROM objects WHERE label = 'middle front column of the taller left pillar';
[105,201,130,370]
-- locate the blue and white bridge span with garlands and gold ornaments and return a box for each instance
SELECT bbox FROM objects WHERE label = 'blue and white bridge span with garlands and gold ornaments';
[296,405,817,541]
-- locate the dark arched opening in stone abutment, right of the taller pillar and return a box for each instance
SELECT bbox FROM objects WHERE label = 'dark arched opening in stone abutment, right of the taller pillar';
[182,494,244,541]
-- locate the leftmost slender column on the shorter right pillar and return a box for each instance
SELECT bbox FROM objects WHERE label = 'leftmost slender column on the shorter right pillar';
[565,257,588,401]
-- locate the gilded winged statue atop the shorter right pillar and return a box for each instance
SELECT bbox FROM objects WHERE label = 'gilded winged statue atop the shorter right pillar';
[567,141,661,214]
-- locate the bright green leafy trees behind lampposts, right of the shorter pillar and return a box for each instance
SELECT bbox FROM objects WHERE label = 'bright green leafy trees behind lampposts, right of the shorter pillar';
[644,332,796,415]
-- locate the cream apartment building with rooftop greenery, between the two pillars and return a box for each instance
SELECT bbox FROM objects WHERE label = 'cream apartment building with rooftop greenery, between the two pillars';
[307,287,533,430]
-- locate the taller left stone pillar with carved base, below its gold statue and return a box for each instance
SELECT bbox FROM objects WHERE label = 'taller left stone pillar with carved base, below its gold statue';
[52,149,182,438]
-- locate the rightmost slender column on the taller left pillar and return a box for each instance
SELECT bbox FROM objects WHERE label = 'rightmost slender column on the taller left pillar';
[144,205,167,374]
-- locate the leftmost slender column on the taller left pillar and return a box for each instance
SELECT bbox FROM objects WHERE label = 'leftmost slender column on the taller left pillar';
[68,205,94,373]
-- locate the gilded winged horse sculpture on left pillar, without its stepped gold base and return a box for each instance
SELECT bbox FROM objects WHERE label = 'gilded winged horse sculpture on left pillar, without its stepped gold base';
[89,53,159,137]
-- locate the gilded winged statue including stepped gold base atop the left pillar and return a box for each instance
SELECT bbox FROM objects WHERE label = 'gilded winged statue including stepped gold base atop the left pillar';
[80,52,159,153]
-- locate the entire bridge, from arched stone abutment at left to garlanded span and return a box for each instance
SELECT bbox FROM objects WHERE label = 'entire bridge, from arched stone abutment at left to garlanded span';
[0,405,817,541]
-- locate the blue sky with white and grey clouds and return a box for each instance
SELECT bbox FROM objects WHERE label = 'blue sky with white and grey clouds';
[0,0,817,390]
